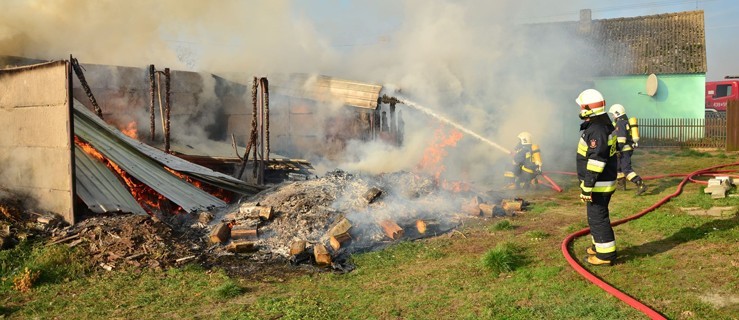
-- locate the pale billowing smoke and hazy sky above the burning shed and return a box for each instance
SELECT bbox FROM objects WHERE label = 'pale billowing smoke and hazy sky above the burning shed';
[0,0,739,179]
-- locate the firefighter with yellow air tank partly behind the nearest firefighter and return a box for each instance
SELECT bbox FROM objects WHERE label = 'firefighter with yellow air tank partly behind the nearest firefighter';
[608,104,647,196]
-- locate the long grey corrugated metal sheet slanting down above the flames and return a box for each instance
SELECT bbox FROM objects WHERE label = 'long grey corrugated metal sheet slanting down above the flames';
[74,100,226,212]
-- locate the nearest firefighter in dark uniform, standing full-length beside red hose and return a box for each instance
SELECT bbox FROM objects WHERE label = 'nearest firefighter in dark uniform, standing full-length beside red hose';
[575,89,618,265]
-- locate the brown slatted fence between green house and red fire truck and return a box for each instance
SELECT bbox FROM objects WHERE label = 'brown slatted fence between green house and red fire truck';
[639,113,727,149]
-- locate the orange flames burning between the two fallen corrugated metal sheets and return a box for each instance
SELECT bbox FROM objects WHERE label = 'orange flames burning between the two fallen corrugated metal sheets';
[74,136,175,215]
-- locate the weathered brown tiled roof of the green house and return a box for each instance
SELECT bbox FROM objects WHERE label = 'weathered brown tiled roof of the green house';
[529,10,706,76]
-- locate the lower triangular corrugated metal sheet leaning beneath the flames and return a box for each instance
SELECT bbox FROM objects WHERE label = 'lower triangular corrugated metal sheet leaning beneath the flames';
[74,146,147,214]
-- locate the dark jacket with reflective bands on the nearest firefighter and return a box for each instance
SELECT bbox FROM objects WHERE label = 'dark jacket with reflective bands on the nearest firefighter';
[577,114,618,193]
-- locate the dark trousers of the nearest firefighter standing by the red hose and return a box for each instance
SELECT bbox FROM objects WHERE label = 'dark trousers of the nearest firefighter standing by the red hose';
[587,192,616,260]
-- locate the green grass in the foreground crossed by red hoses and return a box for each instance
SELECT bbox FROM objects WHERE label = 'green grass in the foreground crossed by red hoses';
[0,149,739,319]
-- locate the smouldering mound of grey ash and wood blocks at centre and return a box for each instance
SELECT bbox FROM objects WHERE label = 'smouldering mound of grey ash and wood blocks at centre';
[210,171,469,265]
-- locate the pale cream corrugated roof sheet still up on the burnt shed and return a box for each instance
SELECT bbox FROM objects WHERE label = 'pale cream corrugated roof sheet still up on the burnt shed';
[270,74,382,109]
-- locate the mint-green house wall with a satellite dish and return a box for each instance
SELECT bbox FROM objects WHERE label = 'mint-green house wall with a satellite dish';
[595,74,706,118]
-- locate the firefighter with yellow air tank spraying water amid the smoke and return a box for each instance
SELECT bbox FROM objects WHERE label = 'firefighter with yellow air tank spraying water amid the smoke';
[504,131,542,189]
